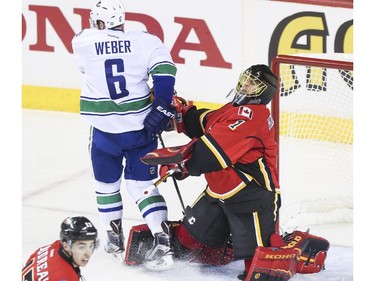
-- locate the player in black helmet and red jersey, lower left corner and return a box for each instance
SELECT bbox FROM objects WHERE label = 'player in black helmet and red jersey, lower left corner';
[22,216,98,281]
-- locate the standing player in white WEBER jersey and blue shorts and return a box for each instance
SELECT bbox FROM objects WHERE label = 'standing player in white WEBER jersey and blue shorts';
[72,0,177,270]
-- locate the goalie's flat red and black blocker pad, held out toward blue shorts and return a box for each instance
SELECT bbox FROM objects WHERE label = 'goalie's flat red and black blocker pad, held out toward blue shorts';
[141,138,197,165]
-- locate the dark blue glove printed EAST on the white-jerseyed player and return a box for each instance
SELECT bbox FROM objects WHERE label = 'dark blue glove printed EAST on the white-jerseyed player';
[143,98,174,138]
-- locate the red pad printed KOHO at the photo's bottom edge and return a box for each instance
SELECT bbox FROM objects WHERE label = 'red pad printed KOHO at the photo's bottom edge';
[245,247,299,281]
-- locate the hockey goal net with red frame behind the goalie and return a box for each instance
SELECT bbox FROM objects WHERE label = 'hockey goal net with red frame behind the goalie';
[271,54,353,230]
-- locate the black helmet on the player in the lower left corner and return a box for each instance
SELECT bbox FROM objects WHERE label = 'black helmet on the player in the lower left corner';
[60,214,98,245]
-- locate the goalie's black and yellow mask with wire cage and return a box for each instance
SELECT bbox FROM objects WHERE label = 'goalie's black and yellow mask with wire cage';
[227,64,277,106]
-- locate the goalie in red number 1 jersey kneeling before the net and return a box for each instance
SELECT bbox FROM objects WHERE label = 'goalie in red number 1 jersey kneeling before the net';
[127,65,329,281]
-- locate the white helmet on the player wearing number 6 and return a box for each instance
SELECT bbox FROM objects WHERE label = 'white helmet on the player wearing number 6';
[90,0,125,29]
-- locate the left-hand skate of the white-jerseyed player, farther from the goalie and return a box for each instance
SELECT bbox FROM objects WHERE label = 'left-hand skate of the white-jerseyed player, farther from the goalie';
[104,220,125,263]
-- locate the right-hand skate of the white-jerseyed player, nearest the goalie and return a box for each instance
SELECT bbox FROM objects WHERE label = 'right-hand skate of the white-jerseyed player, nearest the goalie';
[145,223,174,271]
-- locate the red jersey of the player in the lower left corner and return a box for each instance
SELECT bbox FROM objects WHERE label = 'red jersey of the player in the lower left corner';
[22,240,81,281]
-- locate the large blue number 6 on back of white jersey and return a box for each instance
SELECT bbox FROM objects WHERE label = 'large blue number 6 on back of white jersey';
[104,59,129,100]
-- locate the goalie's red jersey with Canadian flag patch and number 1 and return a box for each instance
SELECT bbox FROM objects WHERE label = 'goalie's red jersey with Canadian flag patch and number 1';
[184,103,279,199]
